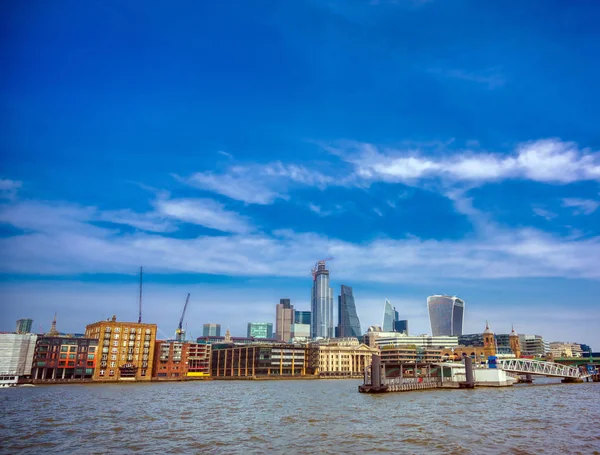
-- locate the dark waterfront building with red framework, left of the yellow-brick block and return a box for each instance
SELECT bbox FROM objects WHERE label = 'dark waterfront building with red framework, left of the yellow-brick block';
[31,335,99,382]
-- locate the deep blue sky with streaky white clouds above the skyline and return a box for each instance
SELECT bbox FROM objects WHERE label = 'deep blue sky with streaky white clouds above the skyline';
[0,0,600,346]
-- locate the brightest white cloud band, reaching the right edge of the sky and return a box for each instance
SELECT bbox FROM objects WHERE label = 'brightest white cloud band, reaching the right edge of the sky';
[338,139,600,184]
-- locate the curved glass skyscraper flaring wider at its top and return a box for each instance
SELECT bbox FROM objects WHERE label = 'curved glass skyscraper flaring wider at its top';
[427,295,465,337]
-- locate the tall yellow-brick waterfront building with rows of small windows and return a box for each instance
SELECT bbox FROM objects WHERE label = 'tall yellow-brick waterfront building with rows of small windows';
[85,316,157,381]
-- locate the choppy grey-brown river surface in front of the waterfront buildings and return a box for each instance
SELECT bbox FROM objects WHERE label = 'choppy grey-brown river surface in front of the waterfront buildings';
[0,380,600,455]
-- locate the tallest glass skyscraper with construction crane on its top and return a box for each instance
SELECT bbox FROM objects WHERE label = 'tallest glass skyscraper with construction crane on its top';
[310,261,334,338]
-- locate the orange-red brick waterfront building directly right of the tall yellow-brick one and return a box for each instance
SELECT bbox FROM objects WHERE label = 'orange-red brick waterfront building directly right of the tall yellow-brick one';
[152,340,211,381]
